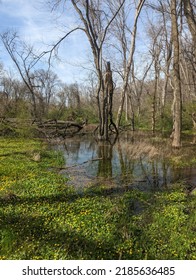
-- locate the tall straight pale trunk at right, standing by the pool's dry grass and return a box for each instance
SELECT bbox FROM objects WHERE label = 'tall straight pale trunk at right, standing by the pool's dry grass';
[171,0,182,148]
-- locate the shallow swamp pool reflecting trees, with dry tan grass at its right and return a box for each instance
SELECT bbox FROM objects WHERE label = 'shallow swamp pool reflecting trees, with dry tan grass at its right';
[56,133,196,191]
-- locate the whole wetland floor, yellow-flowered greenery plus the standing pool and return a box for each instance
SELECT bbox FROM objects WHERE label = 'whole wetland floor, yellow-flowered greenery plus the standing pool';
[0,133,196,260]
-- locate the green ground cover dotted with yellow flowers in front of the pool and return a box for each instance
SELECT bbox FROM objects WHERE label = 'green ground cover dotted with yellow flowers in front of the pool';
[0,138,196,259]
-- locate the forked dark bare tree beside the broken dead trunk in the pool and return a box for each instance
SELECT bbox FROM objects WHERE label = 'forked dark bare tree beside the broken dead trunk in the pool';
[71,0,125,140]
